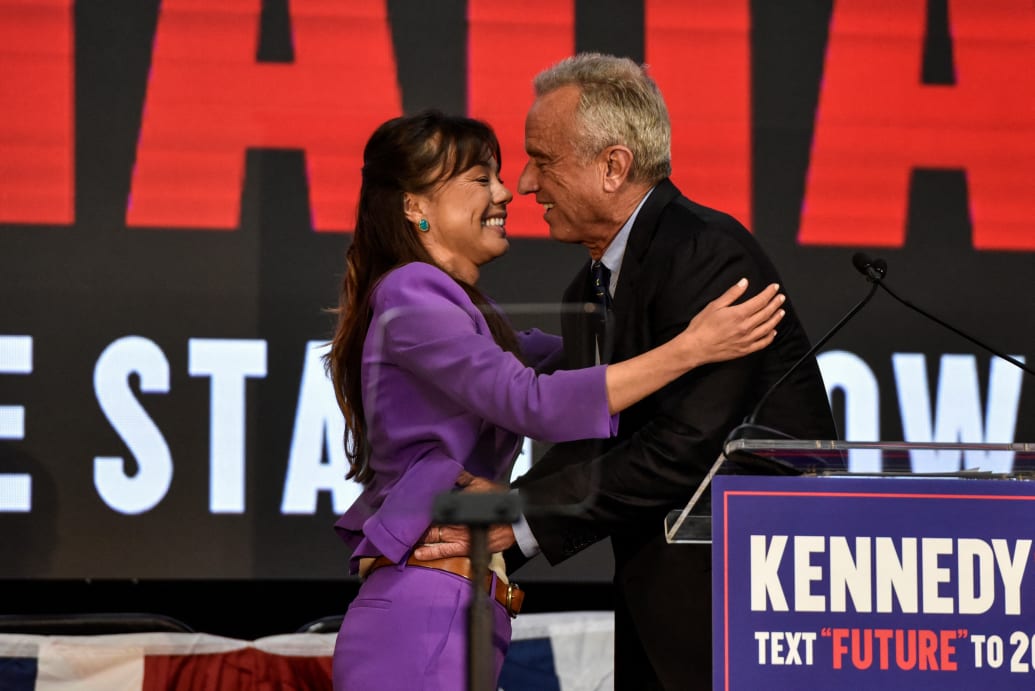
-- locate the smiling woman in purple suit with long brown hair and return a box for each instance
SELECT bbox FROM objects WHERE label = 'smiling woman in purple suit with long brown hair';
[327,112,782,691]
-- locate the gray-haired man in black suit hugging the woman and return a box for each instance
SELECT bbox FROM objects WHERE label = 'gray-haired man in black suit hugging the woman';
[418,54,836,691]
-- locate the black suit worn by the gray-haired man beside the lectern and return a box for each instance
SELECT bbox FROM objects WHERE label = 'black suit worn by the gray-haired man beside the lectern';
[508,180,836,691]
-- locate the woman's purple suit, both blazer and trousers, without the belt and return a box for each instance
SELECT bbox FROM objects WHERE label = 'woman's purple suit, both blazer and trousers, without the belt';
[334,263,617,691]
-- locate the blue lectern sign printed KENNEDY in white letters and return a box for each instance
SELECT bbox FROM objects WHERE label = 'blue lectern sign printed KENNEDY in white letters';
[711,475,1035,691]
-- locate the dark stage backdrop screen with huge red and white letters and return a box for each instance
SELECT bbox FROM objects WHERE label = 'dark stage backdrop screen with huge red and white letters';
[0,0,1035,599]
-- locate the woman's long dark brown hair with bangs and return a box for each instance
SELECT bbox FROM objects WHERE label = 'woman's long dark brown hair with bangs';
[324,111,518,484]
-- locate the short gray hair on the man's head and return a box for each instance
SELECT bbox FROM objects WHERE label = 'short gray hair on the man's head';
[532,53,672,183]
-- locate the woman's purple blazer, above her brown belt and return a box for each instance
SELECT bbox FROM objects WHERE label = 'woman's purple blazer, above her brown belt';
[334,262,618,572]
